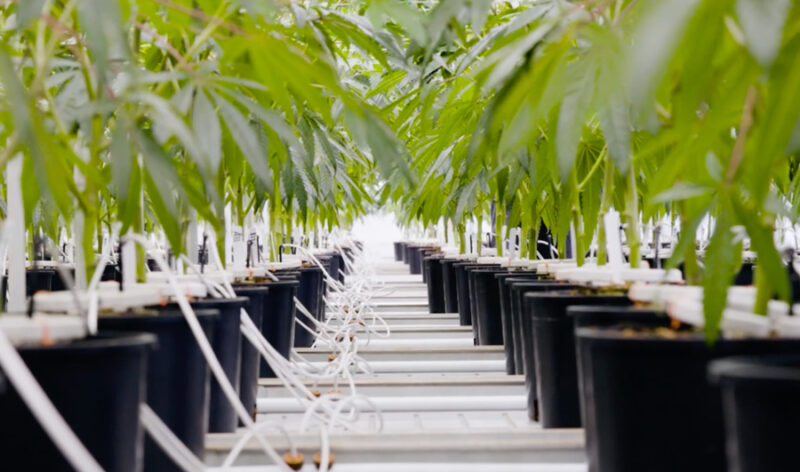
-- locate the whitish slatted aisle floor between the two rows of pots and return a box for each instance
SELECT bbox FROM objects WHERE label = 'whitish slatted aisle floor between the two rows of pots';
[205,261,587,472]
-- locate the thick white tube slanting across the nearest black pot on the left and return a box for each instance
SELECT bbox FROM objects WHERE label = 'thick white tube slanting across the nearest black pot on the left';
[0,324,103,472]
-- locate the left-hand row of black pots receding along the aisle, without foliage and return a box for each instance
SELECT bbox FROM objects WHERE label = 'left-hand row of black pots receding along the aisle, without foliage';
[0,247,339,470]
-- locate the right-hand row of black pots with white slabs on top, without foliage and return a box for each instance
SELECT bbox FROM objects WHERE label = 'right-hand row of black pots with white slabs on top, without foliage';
[404,245,800,471]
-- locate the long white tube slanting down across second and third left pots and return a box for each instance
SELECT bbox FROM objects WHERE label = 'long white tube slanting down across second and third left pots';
[125,234,291,472]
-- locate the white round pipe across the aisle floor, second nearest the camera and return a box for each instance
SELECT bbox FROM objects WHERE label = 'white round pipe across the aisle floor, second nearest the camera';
[257,395,528,414]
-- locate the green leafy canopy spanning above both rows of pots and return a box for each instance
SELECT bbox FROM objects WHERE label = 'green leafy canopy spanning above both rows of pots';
[0,0,800,337]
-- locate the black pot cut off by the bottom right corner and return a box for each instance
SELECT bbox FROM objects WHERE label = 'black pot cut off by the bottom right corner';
[709,355,800,472]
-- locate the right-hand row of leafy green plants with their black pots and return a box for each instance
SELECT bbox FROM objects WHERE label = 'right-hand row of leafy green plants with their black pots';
[380,1,800,471]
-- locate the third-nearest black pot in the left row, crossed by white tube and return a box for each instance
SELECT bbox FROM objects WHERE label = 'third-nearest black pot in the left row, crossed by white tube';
[184,297,248,433]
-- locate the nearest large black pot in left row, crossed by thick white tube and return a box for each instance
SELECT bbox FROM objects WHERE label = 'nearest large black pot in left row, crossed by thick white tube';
[0,333,155,472]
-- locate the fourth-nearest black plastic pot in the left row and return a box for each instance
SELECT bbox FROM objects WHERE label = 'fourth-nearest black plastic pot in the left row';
[233,285,269,420]
